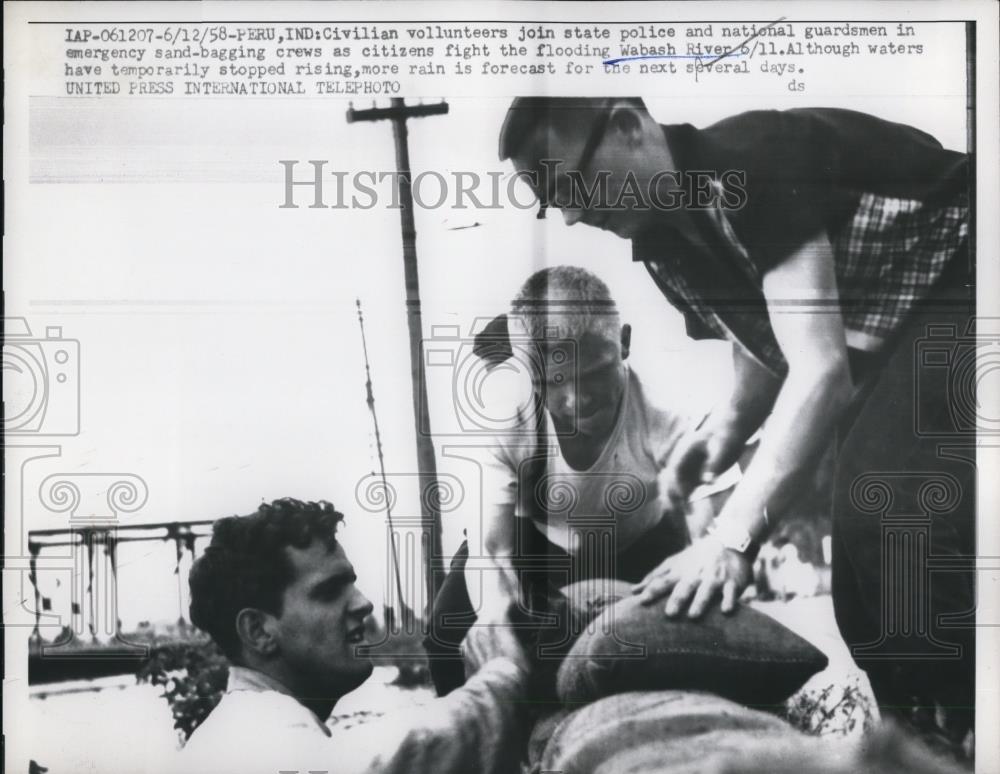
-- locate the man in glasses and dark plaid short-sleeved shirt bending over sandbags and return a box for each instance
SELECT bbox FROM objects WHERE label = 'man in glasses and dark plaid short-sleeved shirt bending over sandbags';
[500,97,975,764]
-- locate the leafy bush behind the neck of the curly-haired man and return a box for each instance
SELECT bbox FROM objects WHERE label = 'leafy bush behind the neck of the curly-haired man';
[136,638,229,740]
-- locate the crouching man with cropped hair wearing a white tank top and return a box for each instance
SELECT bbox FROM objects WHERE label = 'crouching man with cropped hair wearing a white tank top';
[425,266,711,694]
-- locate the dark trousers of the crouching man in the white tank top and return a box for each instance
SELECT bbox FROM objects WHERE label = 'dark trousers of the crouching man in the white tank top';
[424,516,688,696]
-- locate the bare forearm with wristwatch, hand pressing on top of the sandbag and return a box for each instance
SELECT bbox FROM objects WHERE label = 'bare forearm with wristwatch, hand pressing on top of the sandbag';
[634,235,853,617]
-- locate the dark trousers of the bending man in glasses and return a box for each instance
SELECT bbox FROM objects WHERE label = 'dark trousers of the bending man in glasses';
[832,251,976,744]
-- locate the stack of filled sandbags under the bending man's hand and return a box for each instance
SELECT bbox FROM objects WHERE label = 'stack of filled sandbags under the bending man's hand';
[528,579,968,774]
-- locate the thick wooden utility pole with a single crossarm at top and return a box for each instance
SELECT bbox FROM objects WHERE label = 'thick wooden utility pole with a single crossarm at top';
[347,97,448,609]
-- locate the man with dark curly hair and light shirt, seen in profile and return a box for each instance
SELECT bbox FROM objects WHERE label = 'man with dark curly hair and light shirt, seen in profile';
[178,498,526,774]
